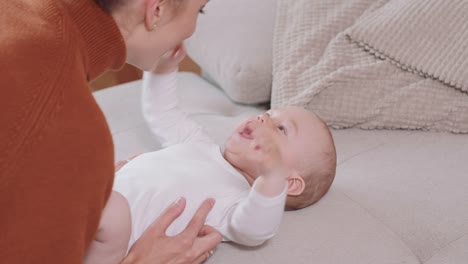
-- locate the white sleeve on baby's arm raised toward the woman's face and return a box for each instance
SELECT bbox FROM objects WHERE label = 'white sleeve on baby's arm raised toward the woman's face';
[142,72,212,147]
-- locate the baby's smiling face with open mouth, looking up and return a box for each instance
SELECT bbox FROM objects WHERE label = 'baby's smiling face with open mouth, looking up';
[224,107,323,183]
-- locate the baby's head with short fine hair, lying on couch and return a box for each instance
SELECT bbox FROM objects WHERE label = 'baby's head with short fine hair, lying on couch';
[224,107,336,209]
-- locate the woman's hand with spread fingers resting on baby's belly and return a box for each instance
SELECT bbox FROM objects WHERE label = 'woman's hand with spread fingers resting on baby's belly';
[122,198,222,264]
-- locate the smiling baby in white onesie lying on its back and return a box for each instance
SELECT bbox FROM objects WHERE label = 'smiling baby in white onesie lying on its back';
[85,48,336,263]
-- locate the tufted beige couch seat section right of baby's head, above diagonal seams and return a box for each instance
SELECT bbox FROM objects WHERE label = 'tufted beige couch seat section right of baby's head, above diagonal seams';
[334,130,468,263]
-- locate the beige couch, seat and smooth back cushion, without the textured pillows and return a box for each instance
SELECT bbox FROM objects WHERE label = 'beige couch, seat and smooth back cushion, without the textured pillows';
[95,0,468,264]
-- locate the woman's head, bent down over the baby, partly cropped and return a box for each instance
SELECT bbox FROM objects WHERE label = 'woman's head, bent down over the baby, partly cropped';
[96,0,209,70]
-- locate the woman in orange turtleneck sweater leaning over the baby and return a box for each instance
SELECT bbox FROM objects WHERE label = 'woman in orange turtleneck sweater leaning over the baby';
[0,0,221,263]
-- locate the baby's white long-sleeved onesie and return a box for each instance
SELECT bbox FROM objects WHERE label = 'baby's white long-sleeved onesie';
[114,73,286,247]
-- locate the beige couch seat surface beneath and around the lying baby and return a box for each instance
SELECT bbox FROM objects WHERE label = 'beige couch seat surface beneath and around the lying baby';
[95,73,468,264]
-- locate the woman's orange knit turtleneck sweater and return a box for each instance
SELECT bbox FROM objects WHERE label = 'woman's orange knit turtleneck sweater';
[0,0,126,264]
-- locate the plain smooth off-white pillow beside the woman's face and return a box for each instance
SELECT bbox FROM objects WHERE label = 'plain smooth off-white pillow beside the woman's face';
[185,0,276,104]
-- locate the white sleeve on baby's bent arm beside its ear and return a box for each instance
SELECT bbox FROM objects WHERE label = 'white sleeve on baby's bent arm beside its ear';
[223,182,287,246]
